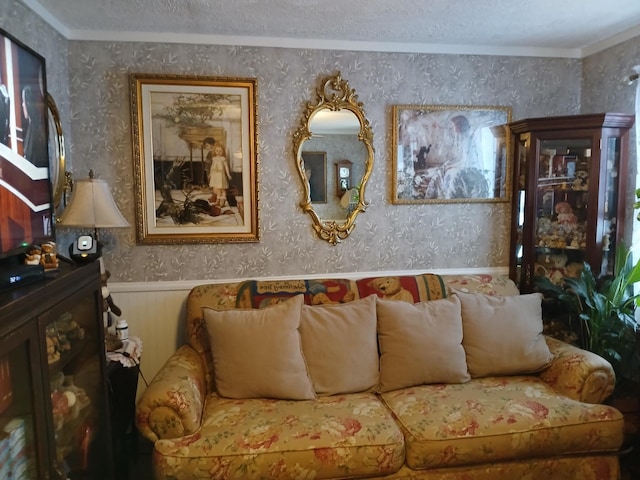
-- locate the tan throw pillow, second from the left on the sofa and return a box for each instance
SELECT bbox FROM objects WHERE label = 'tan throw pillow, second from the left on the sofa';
[300,295,379,395]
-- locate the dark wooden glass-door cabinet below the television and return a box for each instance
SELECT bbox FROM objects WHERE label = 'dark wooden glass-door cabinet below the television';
[0,262,113,480]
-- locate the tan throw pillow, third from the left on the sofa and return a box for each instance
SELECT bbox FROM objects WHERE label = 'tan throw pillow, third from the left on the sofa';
[377,297,471,392]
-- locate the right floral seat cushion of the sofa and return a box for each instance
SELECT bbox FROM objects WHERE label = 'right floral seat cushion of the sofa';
[382,376,624,469]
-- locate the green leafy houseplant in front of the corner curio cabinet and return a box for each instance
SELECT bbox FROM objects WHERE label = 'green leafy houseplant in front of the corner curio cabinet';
[535,244,640,393]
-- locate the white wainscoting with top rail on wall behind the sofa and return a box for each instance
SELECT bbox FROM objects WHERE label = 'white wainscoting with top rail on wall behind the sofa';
[109,267,508,397]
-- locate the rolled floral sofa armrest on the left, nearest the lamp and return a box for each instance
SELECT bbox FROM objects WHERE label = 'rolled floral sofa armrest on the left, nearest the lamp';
[136,345,207,443]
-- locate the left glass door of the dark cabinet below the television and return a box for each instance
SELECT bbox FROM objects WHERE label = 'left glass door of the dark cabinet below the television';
[0,325,47,480]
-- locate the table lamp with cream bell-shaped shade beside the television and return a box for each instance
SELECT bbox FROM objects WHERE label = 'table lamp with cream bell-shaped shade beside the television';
[57,170,129,262]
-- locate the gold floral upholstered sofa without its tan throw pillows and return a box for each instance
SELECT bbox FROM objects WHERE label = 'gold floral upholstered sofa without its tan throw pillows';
[136,275,623,480]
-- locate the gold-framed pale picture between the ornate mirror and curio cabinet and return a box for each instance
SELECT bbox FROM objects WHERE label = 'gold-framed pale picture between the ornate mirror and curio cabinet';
[391,105,511,204]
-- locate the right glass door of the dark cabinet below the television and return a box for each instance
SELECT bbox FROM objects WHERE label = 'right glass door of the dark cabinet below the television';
[40,289,110,479]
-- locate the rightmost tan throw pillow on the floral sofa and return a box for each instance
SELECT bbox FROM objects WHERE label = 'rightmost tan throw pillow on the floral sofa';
[456,292,551,378]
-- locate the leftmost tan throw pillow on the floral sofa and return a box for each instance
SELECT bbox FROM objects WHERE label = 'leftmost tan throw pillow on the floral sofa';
[202,295,315,400]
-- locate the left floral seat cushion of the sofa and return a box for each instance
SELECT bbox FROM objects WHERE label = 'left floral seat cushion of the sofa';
[154,393,404,480]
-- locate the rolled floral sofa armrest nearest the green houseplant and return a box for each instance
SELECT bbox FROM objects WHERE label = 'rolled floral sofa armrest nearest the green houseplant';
[540,337,616,403]
